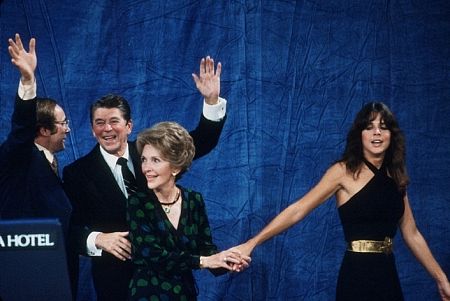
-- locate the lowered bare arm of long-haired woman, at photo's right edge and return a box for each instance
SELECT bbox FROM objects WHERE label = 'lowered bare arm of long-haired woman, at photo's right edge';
[400,195,450,300]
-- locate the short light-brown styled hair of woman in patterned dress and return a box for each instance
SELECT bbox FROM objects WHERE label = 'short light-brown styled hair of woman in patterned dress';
[136,121,195,176]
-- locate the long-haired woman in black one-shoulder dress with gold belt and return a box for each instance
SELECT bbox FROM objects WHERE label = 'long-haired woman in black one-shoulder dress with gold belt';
[236,103,450,301]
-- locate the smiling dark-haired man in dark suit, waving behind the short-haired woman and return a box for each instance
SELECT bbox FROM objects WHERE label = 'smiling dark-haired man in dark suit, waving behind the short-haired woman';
[63,57,226,301]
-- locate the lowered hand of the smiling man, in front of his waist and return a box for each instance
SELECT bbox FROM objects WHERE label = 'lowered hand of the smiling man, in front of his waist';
[95,232,131,261]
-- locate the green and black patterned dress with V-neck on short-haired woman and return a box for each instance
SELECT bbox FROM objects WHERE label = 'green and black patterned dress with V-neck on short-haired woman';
[125,187,217,301]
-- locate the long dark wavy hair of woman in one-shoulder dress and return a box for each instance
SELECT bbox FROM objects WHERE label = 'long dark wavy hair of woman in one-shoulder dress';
[339,102,409,192]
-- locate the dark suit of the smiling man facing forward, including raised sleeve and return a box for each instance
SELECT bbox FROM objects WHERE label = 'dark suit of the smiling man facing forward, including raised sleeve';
[63,116,225,301]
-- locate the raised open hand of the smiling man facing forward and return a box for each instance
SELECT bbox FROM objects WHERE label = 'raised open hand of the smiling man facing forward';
[192,56,222,105]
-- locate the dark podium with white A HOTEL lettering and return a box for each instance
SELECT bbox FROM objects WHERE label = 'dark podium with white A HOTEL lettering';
[0,219,71,301]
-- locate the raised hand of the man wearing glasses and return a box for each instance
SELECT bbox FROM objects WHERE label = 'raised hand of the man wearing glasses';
[8,33,37,84]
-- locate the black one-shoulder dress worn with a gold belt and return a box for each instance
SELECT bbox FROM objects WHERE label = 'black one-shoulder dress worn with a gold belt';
[336,161,405,301]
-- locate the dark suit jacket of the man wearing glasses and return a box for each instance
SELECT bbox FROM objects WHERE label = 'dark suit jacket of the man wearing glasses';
[0,96,72,235]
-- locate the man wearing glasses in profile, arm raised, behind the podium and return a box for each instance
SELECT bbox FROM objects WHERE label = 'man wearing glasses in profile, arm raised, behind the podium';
[0,34,72,237]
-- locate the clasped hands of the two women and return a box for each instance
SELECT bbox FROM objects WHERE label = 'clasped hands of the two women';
[201,249,251,272]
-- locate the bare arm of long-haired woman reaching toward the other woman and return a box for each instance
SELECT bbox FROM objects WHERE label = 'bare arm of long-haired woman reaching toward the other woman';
[236,163,345,256]
